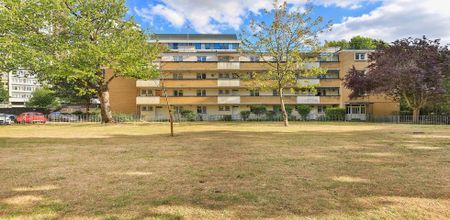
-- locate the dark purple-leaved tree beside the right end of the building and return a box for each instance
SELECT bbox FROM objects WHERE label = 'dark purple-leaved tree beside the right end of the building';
[345,37,449,120]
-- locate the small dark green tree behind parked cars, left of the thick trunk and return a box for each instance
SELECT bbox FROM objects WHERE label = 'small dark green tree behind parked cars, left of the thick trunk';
[25,87,61,109]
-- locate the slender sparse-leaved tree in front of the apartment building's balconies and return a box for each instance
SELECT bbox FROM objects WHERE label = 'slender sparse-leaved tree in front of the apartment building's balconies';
[241,0,331,126]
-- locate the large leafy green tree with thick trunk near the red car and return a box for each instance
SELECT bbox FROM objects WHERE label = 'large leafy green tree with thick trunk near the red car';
[0,0,159,123]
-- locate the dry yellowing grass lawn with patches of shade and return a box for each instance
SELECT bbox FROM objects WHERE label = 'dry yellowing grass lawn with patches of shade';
[0,123,450,219]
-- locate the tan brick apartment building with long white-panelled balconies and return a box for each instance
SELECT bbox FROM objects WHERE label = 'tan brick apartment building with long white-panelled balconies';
[110,34,399,120]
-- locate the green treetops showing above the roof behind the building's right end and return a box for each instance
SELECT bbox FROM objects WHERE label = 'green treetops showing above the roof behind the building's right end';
[325,36,388,50]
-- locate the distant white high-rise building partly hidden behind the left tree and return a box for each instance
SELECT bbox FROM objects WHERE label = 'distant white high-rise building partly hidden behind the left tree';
[8,70,40,107]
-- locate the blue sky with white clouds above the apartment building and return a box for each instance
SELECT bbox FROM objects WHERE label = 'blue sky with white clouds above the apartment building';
[127,0,450,43]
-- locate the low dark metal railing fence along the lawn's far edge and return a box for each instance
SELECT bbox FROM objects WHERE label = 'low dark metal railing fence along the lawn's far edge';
[3,114,450,125]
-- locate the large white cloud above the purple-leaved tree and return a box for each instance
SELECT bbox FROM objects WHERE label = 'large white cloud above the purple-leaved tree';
[322,0,450,43]
